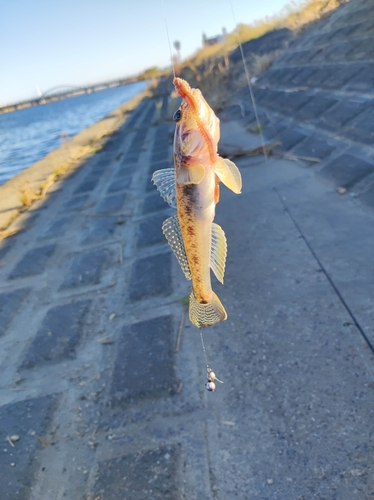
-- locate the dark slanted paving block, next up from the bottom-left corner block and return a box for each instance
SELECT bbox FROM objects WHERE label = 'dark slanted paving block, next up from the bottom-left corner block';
[22,300,91,369]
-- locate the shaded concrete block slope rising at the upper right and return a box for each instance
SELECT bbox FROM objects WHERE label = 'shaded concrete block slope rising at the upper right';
[241,0,374,206]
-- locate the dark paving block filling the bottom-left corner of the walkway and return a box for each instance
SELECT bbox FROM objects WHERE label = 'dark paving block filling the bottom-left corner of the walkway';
[0,395,58,500]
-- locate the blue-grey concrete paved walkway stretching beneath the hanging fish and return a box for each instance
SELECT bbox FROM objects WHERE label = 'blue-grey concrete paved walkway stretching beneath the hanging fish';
[0,84,374,500]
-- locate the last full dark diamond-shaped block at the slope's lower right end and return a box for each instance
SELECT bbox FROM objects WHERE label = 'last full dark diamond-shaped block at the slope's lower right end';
[318,154,374,189]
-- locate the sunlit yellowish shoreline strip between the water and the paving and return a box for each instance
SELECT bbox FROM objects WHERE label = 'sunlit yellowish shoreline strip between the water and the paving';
[0,85,153,234]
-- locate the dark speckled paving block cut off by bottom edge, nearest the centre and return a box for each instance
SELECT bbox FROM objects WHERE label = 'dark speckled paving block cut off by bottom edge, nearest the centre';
[93,445,184,500]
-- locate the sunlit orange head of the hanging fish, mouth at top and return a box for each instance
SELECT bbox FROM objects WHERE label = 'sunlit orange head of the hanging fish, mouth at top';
[173,78,220,161]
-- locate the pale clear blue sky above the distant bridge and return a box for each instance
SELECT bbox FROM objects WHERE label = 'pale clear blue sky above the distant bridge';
[0,0,288,105]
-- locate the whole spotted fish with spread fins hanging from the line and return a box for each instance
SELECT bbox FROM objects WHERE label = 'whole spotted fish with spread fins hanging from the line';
[152,77,242,329]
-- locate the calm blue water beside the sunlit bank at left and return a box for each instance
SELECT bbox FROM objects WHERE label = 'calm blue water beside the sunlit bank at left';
[0,82,147,184]
